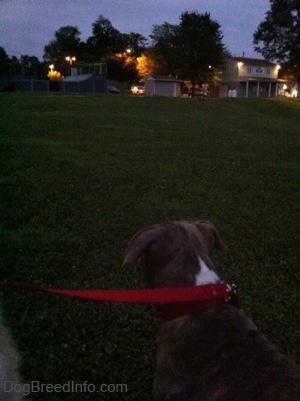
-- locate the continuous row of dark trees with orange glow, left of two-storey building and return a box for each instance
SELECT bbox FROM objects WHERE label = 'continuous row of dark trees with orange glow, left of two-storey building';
[0,12,225,86]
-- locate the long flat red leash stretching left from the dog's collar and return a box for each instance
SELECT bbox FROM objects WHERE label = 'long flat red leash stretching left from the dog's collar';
[0,280,231,303]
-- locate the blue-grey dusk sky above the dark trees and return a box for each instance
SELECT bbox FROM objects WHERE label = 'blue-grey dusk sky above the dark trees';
[0,0,270,60]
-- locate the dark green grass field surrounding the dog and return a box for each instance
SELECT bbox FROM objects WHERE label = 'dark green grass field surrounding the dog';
[0,93,300,401]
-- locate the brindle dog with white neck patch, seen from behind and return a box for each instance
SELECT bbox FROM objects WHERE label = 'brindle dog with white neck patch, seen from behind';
[124,221,300,401]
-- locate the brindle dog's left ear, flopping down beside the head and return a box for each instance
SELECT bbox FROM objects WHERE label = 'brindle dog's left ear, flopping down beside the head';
[123,226,160,266]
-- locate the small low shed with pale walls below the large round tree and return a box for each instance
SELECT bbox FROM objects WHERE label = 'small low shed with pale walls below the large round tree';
[145,75,183,97]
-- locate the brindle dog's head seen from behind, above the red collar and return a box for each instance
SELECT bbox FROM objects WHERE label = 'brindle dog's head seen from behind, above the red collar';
[123,221,226,287]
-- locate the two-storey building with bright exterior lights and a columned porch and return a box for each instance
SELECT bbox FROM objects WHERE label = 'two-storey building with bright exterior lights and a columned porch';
[220,57,287,98]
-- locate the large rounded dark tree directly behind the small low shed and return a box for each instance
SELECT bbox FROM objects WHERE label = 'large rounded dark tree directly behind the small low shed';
[151,12,225,88]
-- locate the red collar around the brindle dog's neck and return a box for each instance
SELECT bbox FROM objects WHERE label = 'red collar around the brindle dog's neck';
[160,283,241,321]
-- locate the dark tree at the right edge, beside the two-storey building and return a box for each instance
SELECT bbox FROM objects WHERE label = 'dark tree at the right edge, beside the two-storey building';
[253,0,300,90]
